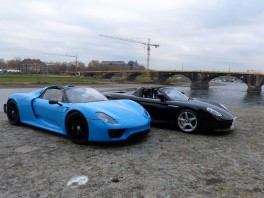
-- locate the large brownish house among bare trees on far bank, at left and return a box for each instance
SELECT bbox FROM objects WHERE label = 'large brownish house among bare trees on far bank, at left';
[19,58,47,74]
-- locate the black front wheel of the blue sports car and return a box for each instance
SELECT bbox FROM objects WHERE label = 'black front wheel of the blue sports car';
[65,112,89,144]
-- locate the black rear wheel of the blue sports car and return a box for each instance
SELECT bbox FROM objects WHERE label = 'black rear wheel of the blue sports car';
[6,100,20,125]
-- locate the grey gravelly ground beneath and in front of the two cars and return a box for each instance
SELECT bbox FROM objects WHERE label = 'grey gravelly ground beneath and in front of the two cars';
[0,108,264,198]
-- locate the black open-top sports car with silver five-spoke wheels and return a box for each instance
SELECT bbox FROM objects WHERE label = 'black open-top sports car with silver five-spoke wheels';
[104,87,236,133]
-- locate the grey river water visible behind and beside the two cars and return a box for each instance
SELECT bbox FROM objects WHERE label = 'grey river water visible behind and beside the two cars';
[0,82,264,112]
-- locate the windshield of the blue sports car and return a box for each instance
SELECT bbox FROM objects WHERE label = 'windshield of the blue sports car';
[66,87,108,103]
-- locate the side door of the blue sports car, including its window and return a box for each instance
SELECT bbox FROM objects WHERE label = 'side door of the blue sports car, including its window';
[33,89,62,128]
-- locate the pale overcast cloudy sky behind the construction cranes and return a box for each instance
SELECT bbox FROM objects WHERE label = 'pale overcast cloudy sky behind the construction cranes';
[0,0,264,72]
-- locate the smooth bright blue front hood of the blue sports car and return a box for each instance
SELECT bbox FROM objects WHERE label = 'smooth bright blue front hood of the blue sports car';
[71,100,145,120]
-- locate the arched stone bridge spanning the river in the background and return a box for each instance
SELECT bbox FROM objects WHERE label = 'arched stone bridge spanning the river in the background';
[80,70,264,92]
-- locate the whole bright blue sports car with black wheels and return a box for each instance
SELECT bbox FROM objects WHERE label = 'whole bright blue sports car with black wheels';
[4,86,151,144]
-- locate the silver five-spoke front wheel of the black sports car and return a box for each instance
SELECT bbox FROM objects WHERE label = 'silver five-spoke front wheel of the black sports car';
[177,109,200,133]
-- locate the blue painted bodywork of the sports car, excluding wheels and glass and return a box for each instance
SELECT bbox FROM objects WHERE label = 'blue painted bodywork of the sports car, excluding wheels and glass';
[4,87,151,142]
